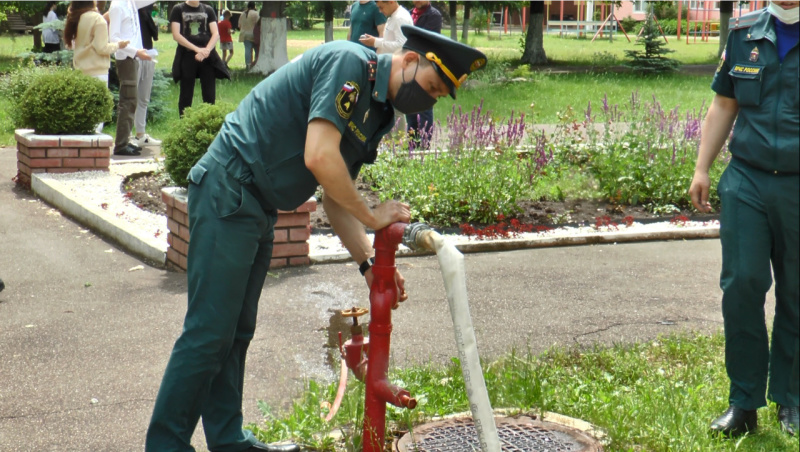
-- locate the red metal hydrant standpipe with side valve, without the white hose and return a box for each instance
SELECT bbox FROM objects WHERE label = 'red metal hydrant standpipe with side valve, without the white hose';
[342,223,417,452]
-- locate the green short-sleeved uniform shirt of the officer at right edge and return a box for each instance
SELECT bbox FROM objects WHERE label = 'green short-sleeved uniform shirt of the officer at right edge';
[711,10,800,173]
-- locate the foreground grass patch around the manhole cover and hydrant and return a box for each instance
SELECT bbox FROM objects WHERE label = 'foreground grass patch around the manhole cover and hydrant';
[250,333,798,452]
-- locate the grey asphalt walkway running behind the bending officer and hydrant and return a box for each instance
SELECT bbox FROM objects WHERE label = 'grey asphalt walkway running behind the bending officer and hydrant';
[0,148,773,451]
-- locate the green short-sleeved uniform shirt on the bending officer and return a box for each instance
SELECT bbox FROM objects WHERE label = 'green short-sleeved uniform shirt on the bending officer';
[205,41,394,210]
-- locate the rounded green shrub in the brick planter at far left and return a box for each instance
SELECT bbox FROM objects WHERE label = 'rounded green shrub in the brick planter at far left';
[17,70,113,135]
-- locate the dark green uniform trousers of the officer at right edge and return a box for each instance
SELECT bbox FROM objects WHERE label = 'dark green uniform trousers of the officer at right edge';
[718,158,800,410]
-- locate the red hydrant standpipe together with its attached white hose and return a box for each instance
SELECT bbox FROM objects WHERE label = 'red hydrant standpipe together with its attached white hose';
[327,223,500,452]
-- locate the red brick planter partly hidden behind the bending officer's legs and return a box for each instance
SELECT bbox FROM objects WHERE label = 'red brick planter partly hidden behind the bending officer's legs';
[161,188,317,271]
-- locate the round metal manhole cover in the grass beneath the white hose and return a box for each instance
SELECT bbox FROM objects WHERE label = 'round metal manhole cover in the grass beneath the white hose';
[395,416,603,452]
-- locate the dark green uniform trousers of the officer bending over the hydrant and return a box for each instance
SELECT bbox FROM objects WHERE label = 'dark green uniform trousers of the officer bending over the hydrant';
[145,154,277,452]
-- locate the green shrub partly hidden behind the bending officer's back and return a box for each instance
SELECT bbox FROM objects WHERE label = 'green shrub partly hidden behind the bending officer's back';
[161,103,235,187]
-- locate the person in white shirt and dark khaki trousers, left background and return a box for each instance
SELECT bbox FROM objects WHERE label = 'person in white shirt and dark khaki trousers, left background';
[108,0,155,155]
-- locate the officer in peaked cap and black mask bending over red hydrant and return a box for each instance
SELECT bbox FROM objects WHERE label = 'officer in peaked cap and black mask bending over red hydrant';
[145,26,486,452]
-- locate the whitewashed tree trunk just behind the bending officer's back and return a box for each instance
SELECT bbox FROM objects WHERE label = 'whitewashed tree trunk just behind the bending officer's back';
[250,2,289,75]
